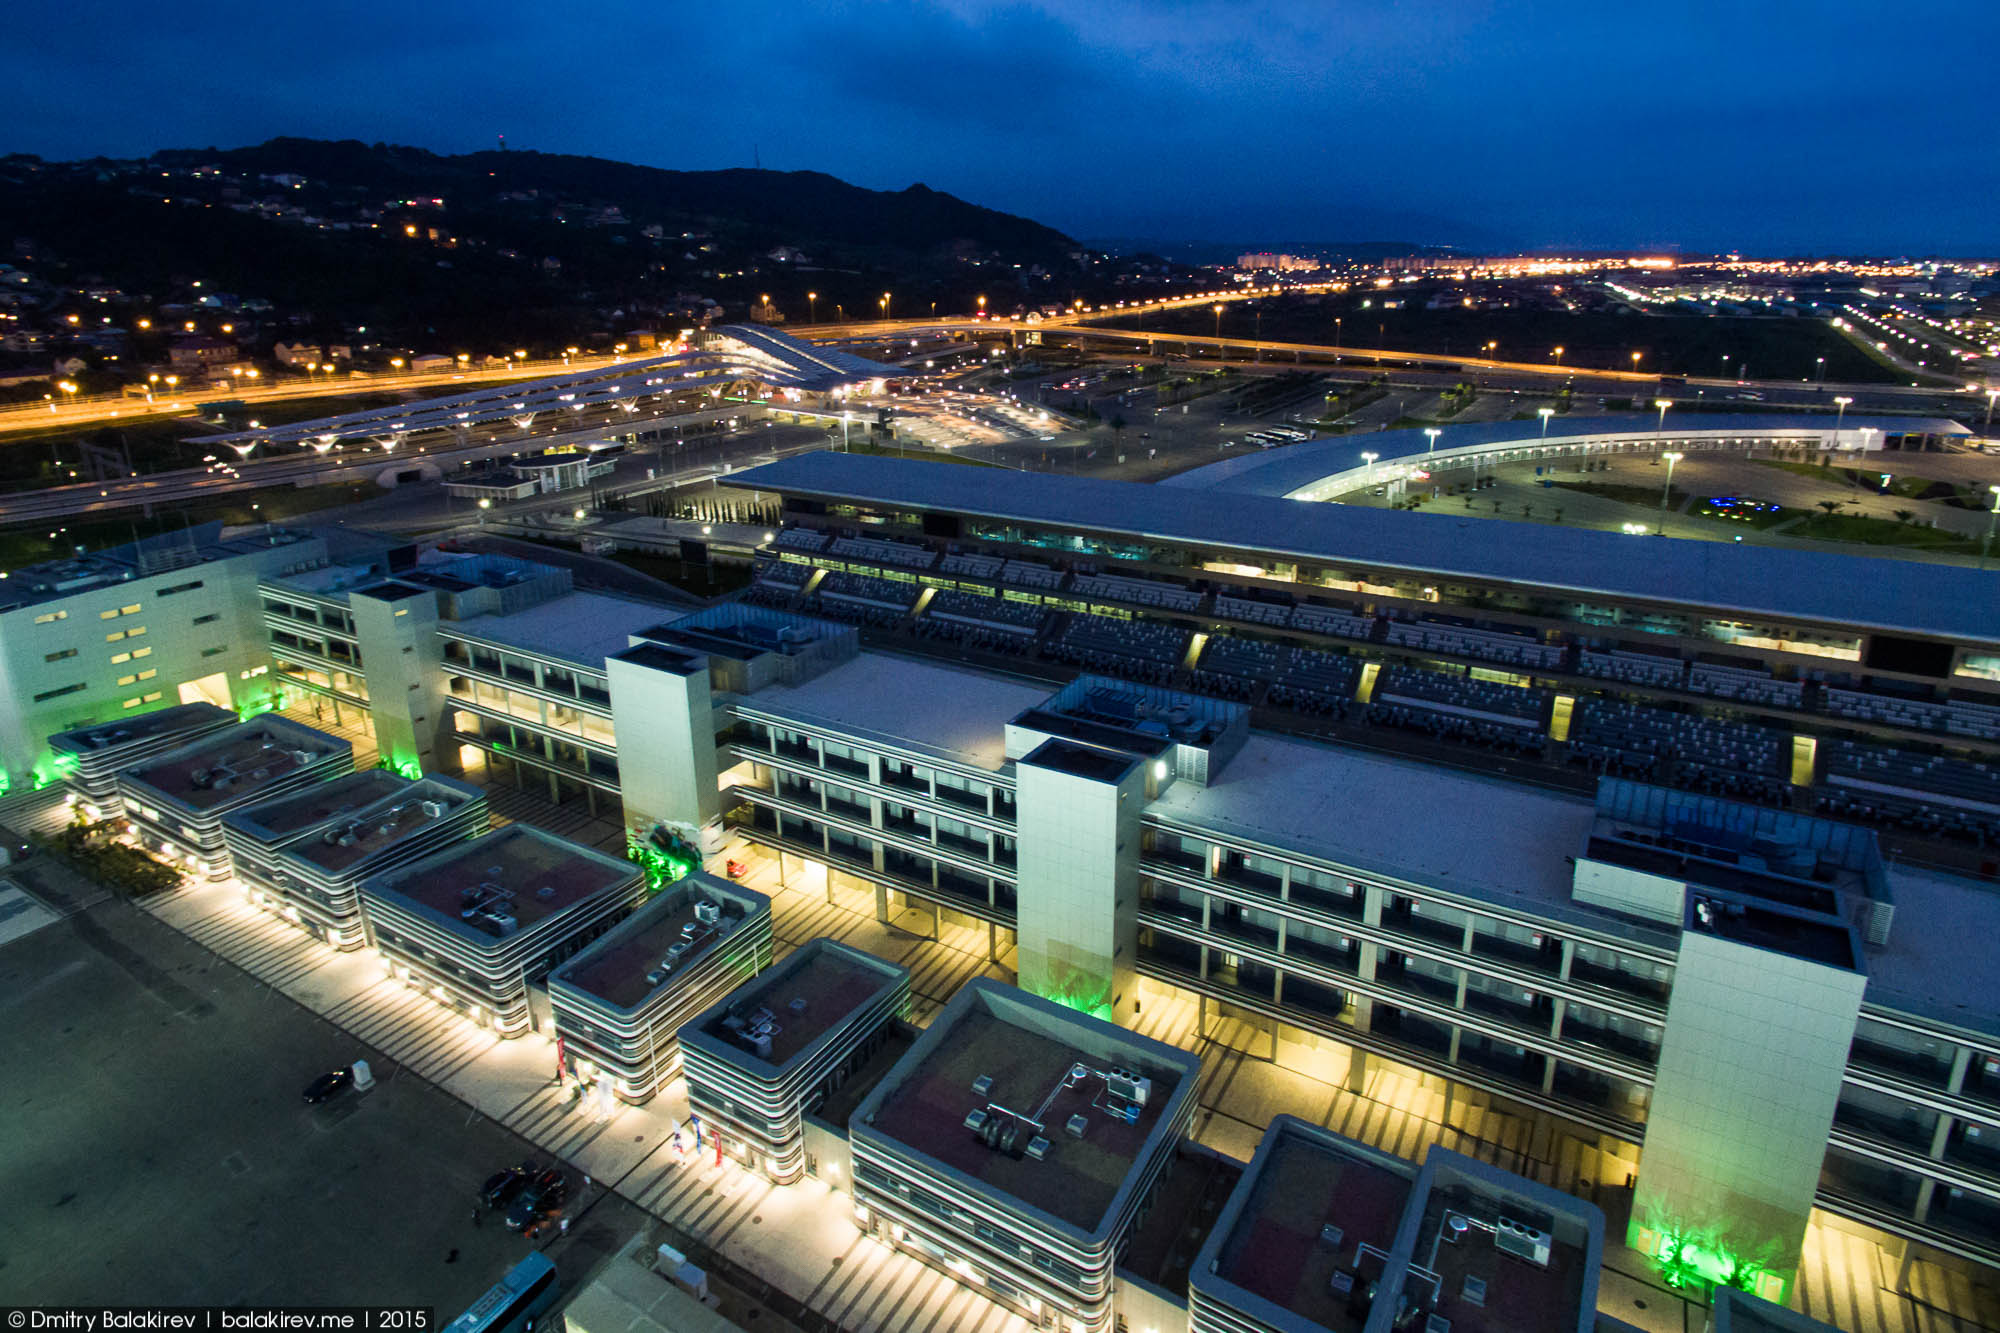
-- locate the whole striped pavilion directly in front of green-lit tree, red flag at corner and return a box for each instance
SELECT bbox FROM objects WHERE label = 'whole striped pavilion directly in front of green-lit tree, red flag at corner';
[548,871,774,1105]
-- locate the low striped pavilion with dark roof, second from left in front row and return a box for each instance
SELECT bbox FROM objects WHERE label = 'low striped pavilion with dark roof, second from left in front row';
[118,715,354,879]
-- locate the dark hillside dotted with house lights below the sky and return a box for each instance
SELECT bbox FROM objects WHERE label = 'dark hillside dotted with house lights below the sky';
[0,138,1078,346]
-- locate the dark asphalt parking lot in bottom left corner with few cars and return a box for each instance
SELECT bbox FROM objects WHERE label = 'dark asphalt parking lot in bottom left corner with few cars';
[0,859,644,1304]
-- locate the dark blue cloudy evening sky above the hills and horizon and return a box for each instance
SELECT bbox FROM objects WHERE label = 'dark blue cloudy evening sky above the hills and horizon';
[0,0,2000,254]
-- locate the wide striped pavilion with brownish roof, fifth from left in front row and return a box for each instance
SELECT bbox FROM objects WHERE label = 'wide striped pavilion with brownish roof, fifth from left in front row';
[362,825,646,1037]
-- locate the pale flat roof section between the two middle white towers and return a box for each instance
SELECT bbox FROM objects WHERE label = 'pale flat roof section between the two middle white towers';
[744,652,1048,771]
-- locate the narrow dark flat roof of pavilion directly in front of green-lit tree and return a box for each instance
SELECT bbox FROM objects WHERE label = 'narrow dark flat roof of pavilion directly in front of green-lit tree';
[556,871,770,1013]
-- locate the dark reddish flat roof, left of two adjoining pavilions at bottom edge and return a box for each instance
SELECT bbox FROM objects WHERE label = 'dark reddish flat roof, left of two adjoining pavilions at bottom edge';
[1214,1117,1416,1333]
